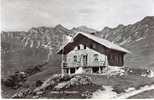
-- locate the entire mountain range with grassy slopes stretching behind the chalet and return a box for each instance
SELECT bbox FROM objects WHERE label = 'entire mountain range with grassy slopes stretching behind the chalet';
[1,16,154,77]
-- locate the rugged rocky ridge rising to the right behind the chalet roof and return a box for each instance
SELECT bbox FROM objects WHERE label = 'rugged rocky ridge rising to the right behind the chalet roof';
[99,16,154,45]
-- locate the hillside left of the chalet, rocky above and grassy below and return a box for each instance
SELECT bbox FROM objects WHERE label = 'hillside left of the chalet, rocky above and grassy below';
[1,25,71,76]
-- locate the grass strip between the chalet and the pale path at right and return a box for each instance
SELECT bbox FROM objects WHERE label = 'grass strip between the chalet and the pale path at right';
[86,75,154,91]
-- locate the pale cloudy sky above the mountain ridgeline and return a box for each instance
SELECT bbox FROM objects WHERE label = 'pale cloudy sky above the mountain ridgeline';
[0,0,154,31]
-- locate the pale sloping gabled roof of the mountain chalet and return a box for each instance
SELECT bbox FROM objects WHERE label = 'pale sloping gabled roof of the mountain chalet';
[57,32,130,53]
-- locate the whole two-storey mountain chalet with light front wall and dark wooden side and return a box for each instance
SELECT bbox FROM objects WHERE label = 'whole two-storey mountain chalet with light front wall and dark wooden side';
[57,32,130,74]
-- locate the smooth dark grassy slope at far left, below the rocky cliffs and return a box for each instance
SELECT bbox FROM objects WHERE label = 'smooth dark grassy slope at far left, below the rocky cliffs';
[1,48,48,77]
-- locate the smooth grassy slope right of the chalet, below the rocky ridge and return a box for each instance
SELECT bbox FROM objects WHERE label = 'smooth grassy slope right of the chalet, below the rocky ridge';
[125,35,154,71]
